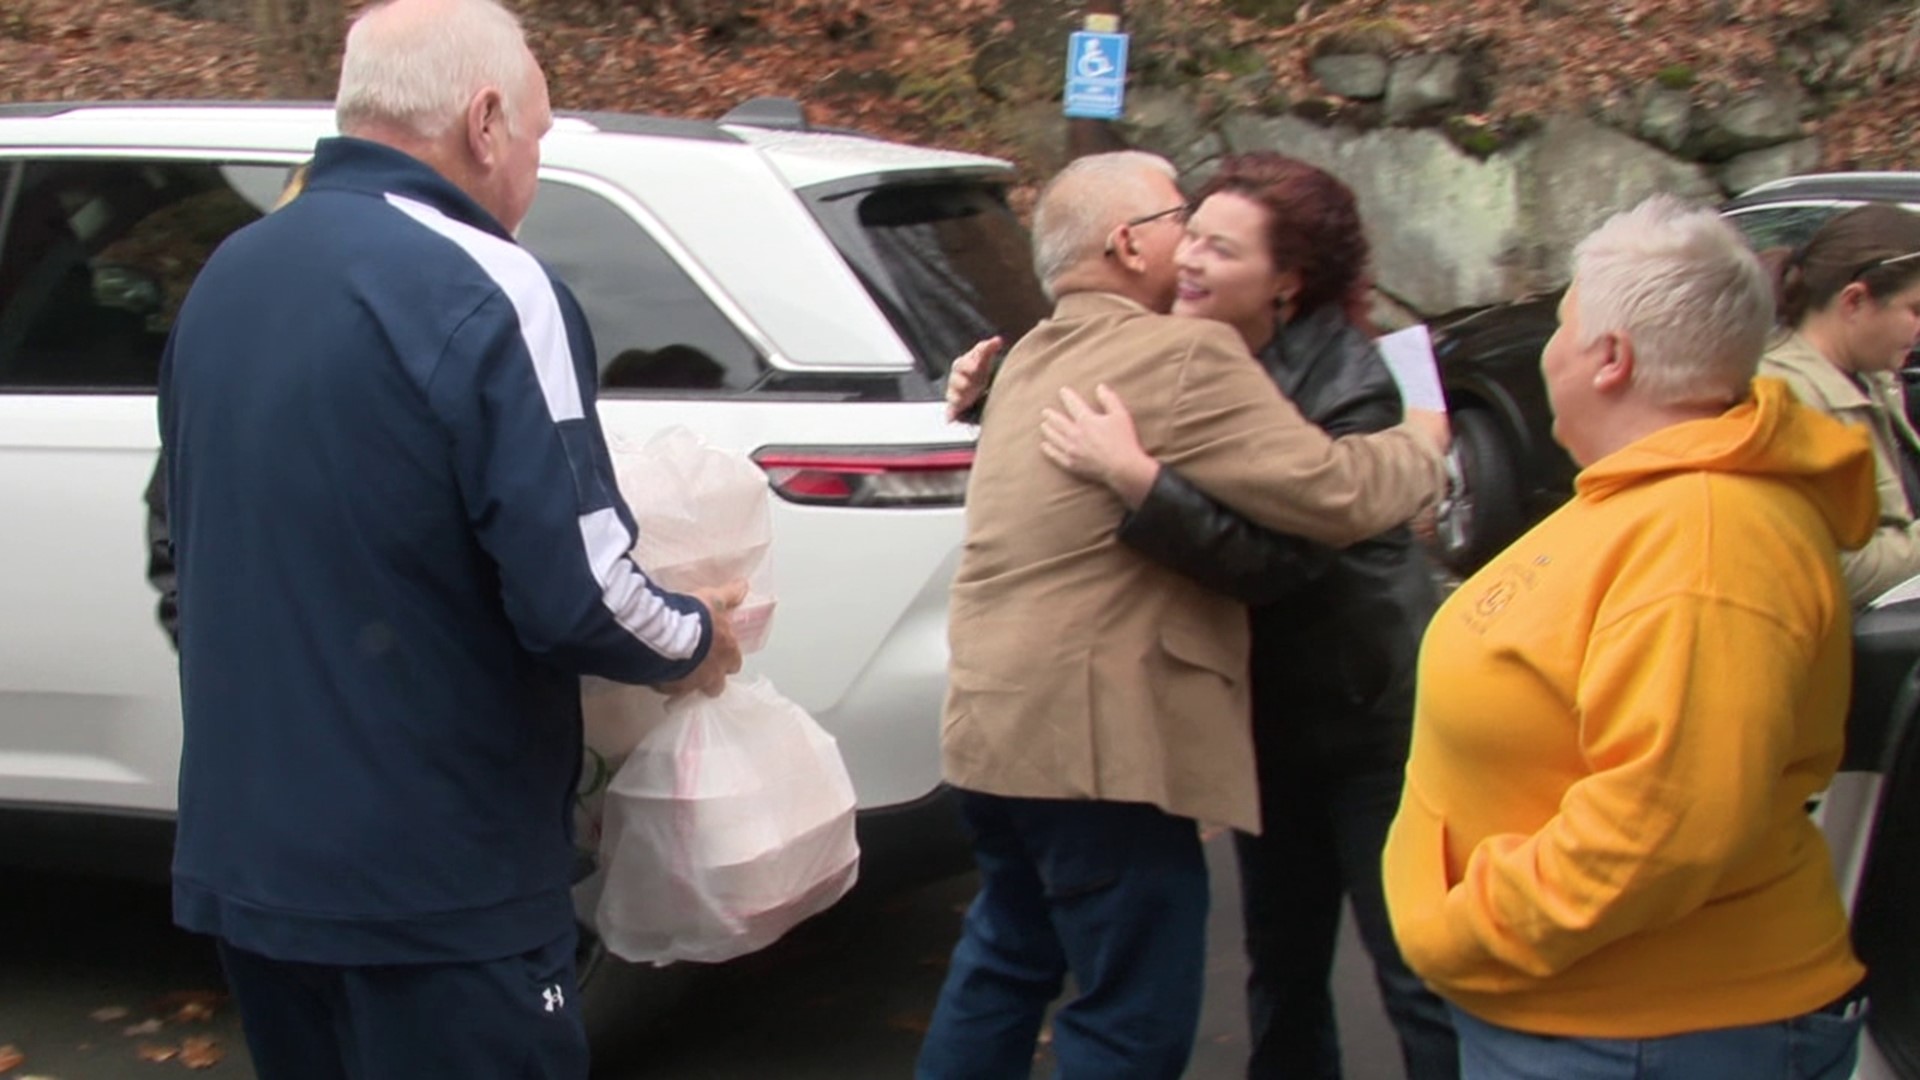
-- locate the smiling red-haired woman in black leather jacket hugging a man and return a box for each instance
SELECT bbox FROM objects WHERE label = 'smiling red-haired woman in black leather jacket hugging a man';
[956,154,1459,1080]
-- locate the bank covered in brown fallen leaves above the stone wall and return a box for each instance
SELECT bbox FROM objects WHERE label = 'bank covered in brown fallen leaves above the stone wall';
[0,0,1920,169]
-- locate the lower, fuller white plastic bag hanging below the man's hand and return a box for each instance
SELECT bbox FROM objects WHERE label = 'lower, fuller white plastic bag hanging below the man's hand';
[595,678,860,965]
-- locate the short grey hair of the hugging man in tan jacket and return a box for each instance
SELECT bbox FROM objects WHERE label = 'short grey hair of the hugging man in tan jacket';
[1033,150,1179,296]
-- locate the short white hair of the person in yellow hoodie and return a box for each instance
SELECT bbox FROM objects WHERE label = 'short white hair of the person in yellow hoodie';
[1572,194,1774,405]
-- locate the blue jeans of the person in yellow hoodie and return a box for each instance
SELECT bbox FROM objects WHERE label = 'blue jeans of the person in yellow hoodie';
[1453,1009,1864,1080]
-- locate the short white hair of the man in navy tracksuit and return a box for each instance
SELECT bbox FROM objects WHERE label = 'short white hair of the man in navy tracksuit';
[334,0,530,138]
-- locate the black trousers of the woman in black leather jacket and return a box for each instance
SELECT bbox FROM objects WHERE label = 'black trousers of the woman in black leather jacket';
[1233,748,1459,1080]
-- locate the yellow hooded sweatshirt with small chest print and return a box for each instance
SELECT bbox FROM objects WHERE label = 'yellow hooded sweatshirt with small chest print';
[1384,379,1876,1038]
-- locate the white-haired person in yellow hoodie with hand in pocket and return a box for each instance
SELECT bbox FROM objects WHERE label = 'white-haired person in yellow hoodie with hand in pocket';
[1384,196,1876,1080]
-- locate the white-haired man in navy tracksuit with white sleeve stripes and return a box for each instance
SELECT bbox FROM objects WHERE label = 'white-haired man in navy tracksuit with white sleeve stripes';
[159,0,739,1080]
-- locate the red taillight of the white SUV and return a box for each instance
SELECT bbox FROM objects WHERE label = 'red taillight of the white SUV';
[753,446,973,507]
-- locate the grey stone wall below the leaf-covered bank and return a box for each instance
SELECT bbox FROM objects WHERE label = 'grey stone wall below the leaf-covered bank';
[996,42,1843,315]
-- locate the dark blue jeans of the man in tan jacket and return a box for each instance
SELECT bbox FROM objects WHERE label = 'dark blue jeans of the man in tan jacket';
[916,780,1208,1080]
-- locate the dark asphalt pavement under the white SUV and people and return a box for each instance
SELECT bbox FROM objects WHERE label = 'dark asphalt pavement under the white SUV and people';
[0,840,1402,1080]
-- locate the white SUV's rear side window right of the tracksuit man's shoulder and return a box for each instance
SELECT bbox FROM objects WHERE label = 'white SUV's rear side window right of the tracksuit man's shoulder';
[520,181,766,394]
